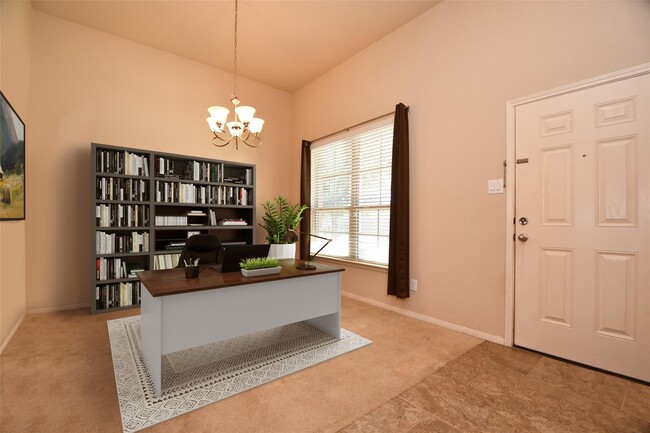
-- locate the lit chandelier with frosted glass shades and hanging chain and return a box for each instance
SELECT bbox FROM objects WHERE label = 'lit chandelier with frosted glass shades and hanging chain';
[206,0,264,149]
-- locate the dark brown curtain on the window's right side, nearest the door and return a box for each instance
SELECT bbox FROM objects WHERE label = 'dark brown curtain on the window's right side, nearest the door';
[388,103,410,298]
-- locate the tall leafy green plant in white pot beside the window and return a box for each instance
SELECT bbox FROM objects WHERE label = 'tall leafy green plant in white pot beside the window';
[260,195,308,259]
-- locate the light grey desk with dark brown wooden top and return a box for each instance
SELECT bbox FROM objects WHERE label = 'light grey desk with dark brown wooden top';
[138,260,344,397]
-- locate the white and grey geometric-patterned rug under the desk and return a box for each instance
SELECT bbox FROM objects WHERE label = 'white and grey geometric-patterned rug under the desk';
[108,316,372,433]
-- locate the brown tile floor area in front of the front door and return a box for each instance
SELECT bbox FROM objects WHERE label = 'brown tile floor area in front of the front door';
[339,342,650,433]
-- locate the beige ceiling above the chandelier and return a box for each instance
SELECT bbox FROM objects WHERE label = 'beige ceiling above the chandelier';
[32,0,439,92]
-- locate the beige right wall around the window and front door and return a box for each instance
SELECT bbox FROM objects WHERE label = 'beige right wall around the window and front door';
[293,1,650,339]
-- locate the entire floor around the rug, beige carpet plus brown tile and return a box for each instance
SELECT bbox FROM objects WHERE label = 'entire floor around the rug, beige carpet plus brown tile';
[0,298,650,433]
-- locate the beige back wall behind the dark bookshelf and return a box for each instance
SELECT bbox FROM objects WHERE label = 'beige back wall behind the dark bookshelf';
[27,12,292,311]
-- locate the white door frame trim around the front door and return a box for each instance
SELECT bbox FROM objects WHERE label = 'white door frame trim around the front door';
[503,63,650,346]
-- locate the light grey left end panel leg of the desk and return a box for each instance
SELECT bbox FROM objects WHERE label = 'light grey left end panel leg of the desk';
[140,284,162,398]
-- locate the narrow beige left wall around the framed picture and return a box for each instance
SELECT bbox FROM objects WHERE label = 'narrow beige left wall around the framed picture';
[0,1,32,347]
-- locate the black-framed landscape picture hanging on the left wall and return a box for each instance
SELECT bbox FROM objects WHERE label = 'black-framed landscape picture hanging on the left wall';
[0,92,25,221]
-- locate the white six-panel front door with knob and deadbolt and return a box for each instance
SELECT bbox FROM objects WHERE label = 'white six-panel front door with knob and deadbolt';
[514,74,650,381]
